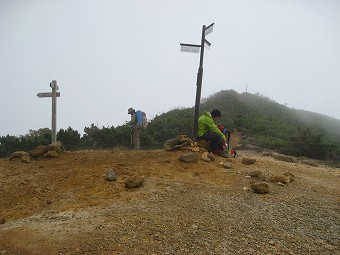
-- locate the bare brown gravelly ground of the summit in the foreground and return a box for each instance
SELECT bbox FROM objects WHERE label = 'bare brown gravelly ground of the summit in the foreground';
[0,149,340,255]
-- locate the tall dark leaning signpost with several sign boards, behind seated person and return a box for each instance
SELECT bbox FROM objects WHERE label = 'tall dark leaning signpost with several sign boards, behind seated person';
[180,23,214,141]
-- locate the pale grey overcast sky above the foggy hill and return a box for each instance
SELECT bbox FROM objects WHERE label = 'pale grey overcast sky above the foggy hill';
[0,0,340,136]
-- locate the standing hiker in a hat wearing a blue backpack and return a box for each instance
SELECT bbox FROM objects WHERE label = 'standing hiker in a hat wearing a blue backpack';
[128,107,147,150]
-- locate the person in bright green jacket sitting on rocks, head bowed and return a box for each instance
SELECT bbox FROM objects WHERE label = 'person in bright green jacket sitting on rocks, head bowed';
[197,109,228,157]
